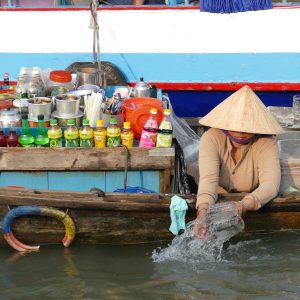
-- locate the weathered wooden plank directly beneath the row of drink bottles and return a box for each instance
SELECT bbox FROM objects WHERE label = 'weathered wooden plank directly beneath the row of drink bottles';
[0,147,174,171]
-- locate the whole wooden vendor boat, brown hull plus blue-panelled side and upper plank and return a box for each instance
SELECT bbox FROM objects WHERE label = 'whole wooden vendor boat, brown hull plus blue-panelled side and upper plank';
[0,147,300,248]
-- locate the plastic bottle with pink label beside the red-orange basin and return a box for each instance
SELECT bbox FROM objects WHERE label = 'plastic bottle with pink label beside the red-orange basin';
[139,107,158,148]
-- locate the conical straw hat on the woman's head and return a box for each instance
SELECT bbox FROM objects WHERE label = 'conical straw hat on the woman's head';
[199,85,283,134]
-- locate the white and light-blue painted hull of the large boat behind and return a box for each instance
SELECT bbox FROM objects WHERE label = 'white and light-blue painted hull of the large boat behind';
[0,7,300,115]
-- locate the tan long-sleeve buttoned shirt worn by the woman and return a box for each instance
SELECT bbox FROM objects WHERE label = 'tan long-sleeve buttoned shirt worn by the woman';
[197,128,281,209]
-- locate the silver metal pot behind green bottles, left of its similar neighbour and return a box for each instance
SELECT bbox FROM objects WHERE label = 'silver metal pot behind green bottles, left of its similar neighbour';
[28,97,53,120]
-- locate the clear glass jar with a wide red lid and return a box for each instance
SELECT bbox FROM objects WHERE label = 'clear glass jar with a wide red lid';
[47,70,74,96]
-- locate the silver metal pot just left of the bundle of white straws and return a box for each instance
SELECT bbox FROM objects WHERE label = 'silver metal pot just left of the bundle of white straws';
[53,94,80,117]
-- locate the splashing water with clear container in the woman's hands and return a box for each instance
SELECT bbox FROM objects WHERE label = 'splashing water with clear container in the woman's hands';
[152,202,244,264]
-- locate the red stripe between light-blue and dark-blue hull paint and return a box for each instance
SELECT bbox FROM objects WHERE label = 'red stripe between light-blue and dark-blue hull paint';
[129,82,300,92]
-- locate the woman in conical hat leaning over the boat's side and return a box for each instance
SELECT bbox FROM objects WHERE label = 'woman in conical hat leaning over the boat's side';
[194,86,283,237]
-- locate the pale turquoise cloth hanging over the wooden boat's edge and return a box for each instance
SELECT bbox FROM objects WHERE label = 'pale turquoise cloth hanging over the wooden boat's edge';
[169,196,188,235]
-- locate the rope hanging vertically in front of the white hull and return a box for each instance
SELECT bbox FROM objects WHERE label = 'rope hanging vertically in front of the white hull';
[90,0,103,85]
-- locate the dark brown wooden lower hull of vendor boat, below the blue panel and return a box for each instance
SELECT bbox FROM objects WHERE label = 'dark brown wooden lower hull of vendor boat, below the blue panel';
[0,188,300,244]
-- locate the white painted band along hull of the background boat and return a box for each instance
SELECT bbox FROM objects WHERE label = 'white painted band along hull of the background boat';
[0,8,300,53]
